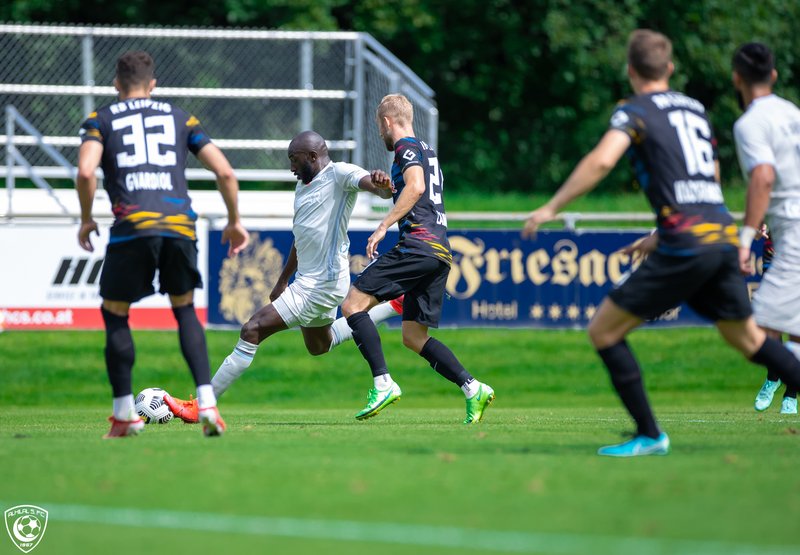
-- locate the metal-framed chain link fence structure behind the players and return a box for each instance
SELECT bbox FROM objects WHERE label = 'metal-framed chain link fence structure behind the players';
[0,25,438,185]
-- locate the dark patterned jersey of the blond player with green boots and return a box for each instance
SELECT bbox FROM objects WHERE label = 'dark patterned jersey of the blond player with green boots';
[392,137,453,265]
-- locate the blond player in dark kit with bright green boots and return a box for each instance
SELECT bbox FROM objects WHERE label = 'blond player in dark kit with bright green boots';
[342,94,494,424]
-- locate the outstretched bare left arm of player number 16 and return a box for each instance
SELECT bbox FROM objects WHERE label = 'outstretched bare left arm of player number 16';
[522,129,631,238]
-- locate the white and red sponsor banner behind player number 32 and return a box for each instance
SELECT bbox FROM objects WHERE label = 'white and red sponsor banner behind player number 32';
[0,221,208,329]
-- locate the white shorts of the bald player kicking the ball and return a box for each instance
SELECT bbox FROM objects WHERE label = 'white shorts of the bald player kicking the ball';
[272,274,350,328]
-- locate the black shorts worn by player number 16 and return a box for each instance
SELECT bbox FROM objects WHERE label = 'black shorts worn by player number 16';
[608,249,753,322]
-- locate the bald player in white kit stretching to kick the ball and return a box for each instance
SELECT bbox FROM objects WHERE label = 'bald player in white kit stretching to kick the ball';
[164,131,402,423]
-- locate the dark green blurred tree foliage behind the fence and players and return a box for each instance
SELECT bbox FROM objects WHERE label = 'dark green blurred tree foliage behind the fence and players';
[0,0,800,193]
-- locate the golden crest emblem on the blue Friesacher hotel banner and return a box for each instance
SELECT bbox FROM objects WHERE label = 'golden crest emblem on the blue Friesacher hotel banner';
[219,233,283,324]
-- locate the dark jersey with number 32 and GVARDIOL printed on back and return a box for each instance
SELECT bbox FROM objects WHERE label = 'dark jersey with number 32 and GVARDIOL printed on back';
[80,98,210,243]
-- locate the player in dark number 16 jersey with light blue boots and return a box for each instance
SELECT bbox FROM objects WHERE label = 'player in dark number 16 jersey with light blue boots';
[523,29,800,457]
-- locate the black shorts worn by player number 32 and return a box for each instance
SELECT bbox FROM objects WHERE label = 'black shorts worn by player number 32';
[100,236,203,303]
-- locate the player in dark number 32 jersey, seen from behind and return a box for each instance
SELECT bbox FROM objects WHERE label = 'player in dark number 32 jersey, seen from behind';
[77,51,248,438]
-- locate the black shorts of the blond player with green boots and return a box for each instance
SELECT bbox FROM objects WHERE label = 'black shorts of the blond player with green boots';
[353,249,450,328]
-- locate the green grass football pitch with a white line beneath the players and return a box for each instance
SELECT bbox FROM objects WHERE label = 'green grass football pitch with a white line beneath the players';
[0,329,800,555]
